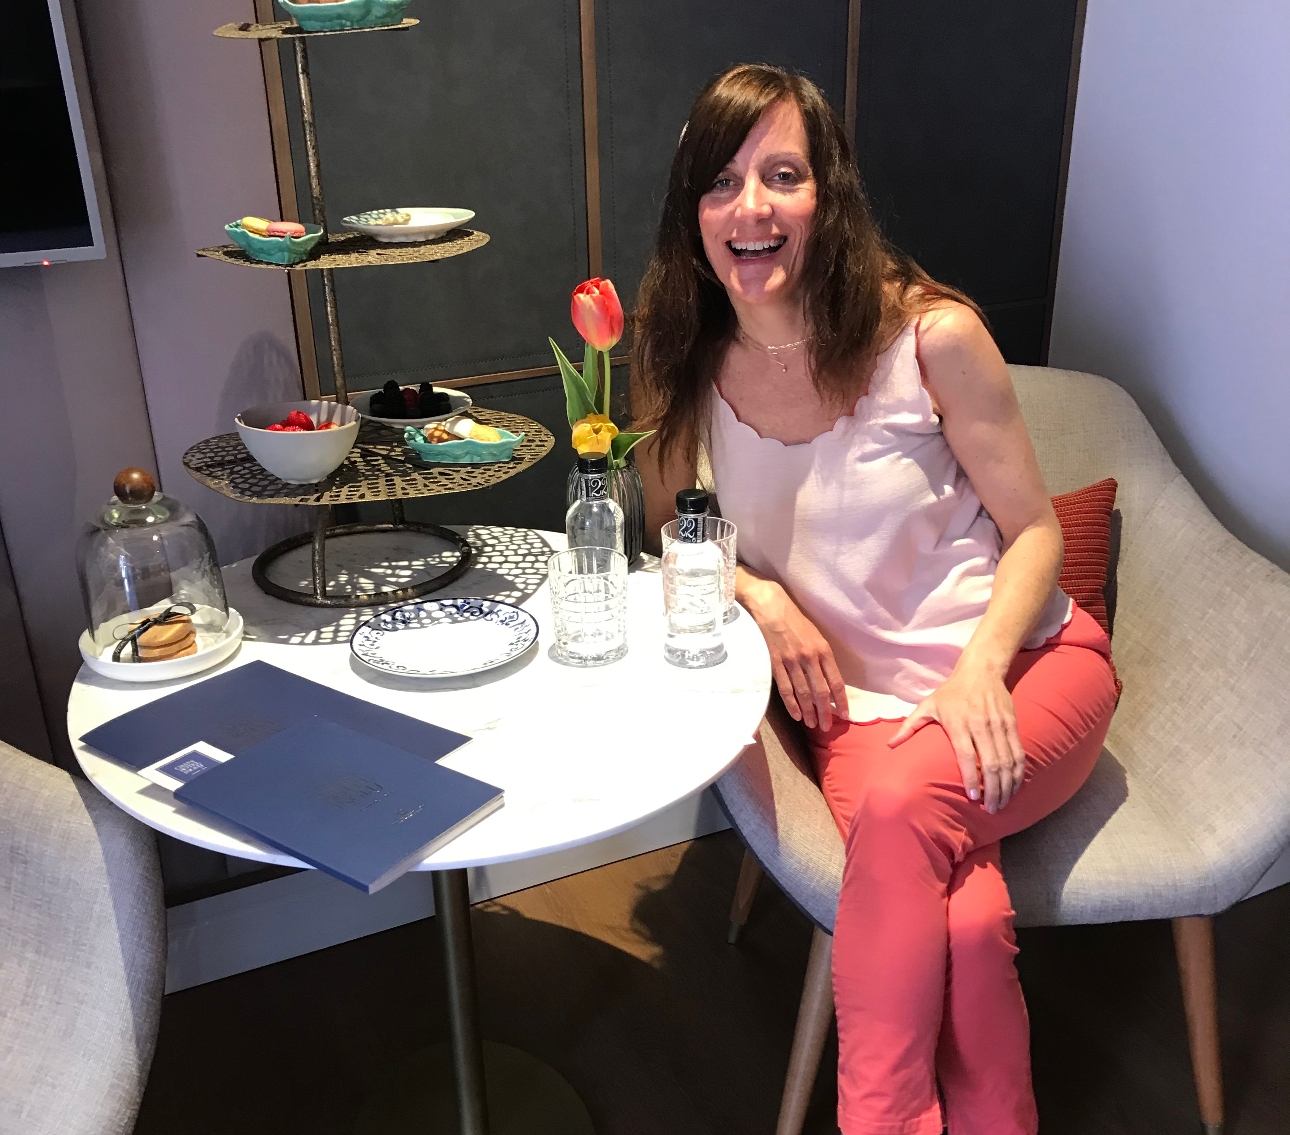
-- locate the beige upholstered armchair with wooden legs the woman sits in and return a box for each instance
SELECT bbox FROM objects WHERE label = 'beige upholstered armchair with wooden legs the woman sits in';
[717,366,1290,1135]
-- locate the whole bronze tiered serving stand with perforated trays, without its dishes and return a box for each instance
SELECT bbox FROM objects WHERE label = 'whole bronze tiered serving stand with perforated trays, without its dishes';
[183,19,555,607]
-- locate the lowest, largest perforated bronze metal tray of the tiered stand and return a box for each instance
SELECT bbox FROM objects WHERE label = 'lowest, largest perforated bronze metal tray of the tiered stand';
[183,406,555,504]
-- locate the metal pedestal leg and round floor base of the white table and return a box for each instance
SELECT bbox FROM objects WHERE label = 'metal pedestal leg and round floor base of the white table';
[356,871,595,1135]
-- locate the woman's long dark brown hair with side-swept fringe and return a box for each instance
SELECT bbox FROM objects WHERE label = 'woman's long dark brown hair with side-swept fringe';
[632,63,984,466]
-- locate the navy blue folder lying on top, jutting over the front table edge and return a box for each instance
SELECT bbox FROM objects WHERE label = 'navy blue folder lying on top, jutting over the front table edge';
[174,717,502,895]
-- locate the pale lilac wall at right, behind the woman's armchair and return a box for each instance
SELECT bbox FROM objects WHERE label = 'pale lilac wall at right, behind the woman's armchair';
[1049,0,1290,569]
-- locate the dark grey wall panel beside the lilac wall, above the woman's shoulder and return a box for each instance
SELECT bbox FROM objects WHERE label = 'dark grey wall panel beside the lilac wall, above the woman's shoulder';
[857,0,1076,362]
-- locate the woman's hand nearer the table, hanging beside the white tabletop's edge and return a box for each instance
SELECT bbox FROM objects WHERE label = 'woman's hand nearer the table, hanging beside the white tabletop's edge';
[735,565,846,730]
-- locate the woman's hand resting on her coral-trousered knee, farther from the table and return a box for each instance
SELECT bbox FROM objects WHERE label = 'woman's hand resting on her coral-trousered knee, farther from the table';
[888,668,1026,815]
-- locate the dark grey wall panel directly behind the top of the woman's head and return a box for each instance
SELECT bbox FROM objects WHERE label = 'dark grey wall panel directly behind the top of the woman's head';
[596,0,851,312]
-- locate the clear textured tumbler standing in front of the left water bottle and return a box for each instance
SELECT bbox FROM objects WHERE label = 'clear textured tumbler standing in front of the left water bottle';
[547,548,627,666]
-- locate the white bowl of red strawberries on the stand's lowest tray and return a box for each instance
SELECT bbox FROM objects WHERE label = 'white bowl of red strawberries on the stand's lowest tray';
[235,401,360,485]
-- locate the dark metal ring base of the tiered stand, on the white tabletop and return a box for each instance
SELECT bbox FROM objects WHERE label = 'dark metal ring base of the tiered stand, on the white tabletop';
[250,500,475,607]
